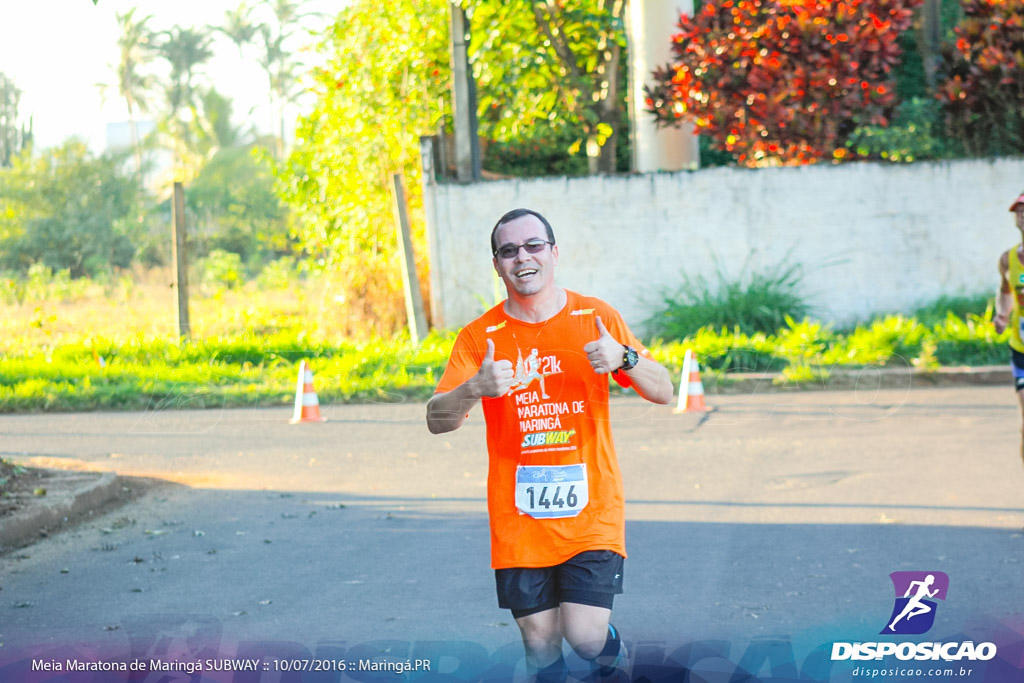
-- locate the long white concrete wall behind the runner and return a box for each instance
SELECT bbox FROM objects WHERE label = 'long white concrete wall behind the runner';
[427,159,1024,331]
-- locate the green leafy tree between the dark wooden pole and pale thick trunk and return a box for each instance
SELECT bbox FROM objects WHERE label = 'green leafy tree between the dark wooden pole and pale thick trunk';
[467,0,626,173]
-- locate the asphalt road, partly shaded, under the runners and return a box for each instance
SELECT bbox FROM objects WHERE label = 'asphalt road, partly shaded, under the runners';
[0,383,1024,681]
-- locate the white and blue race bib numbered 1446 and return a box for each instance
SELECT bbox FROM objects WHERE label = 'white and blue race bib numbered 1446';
[515,463,590,519]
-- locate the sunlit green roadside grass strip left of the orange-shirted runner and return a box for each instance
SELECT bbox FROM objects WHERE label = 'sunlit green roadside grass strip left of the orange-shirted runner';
[0,334,453,413]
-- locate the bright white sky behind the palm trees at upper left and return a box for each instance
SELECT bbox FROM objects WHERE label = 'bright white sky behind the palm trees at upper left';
[0,0,341,152]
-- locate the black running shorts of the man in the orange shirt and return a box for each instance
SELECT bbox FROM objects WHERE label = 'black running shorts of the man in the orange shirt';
[495,550,624,618]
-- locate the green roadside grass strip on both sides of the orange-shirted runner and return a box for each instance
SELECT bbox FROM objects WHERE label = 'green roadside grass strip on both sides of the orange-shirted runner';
[0,313,1007,413]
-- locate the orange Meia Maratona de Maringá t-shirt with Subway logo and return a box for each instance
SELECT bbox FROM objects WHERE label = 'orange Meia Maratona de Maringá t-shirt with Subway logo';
[435,291,649,569]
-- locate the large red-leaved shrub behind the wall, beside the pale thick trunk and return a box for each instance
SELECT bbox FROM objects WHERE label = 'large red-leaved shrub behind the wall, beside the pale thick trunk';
[647,0,920,166]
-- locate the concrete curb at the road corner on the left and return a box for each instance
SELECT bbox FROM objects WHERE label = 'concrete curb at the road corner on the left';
[0,472,122,552]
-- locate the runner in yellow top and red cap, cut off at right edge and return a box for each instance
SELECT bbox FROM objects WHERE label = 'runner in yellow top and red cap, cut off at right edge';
[992,194,1024,471]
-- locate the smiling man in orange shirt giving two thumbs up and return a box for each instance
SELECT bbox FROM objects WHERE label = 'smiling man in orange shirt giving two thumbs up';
[427,209,673,683]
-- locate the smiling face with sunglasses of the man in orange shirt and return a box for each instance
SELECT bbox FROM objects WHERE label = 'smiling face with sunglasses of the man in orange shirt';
[494,214,558,298]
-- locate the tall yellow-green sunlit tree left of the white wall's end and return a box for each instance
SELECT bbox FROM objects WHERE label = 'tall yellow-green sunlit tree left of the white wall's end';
[279,0,450,334]
